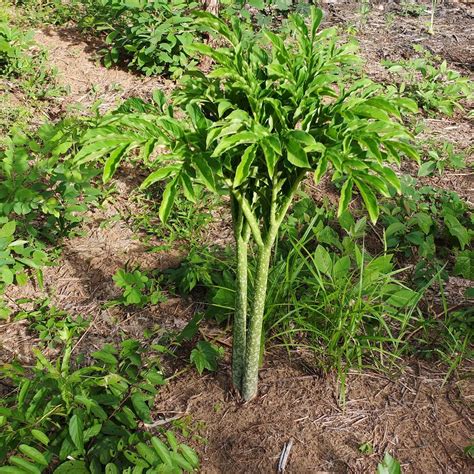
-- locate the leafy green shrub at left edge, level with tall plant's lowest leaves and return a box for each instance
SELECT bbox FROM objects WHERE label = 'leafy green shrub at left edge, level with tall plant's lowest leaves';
[0,121,100,242]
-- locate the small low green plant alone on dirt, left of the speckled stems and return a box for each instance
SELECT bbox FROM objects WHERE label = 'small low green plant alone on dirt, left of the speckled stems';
[112,269,166,307]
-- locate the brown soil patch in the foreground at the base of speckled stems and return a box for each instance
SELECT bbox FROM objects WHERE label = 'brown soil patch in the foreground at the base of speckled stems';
[155,351,474,474]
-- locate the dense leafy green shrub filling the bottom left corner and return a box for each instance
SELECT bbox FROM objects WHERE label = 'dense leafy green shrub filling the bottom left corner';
[0,330,199,473]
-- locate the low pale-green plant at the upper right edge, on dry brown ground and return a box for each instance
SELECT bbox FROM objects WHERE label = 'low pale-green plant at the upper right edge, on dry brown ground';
[383,45,473,115]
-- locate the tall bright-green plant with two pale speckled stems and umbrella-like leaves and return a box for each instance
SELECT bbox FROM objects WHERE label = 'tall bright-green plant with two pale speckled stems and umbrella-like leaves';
[77,8,417,400]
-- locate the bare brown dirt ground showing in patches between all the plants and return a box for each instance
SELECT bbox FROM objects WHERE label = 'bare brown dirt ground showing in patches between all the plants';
[0,2,474,474]
